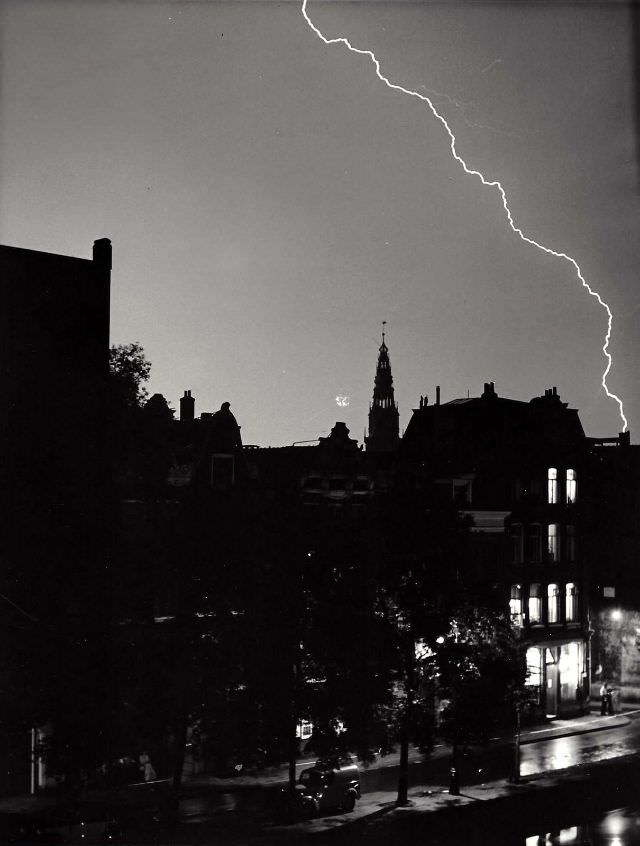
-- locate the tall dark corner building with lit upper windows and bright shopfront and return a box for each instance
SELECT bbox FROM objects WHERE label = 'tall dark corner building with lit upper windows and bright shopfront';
[401,383,589,717]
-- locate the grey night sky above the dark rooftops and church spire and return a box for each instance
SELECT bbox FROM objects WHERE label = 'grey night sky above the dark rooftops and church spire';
[0,0,640,445]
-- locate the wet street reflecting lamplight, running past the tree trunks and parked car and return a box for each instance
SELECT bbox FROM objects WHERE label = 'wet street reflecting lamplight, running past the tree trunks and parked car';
[0,712,640,846]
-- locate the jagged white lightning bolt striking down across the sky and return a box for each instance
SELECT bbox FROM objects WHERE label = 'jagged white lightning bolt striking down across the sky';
[301,0,628,432]
